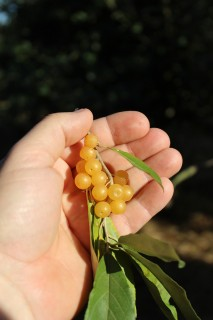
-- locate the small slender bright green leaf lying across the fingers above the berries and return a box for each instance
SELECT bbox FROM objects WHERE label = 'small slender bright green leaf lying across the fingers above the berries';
[110,148,163,189]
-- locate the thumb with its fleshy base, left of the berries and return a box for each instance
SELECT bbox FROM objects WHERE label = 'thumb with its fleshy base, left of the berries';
[0,109,93,261]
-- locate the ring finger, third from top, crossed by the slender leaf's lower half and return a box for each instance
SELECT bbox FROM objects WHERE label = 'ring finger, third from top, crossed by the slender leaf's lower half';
[127,148,182,192]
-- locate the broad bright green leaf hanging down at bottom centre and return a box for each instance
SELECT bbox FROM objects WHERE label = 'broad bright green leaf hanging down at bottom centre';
[84,253,136,320]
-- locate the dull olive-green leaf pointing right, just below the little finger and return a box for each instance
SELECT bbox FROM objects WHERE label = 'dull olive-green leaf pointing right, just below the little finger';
[118,233,185,268]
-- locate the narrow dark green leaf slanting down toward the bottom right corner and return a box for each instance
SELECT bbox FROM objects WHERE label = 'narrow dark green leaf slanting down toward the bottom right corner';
[125,247,200,320]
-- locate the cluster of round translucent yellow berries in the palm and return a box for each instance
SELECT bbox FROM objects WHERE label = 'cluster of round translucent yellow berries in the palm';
[75,133,134,218]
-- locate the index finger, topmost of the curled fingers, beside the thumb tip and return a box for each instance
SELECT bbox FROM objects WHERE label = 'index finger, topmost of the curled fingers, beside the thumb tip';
[91,111,149,146]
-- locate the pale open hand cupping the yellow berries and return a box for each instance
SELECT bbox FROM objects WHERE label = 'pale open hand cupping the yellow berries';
[0,109,182,320]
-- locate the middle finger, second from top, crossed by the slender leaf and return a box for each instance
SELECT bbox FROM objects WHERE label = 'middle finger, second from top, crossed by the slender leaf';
[101,128,170,171]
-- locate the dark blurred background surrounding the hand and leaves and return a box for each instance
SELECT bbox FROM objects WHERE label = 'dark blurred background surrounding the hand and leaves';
[0,0,213,320]
